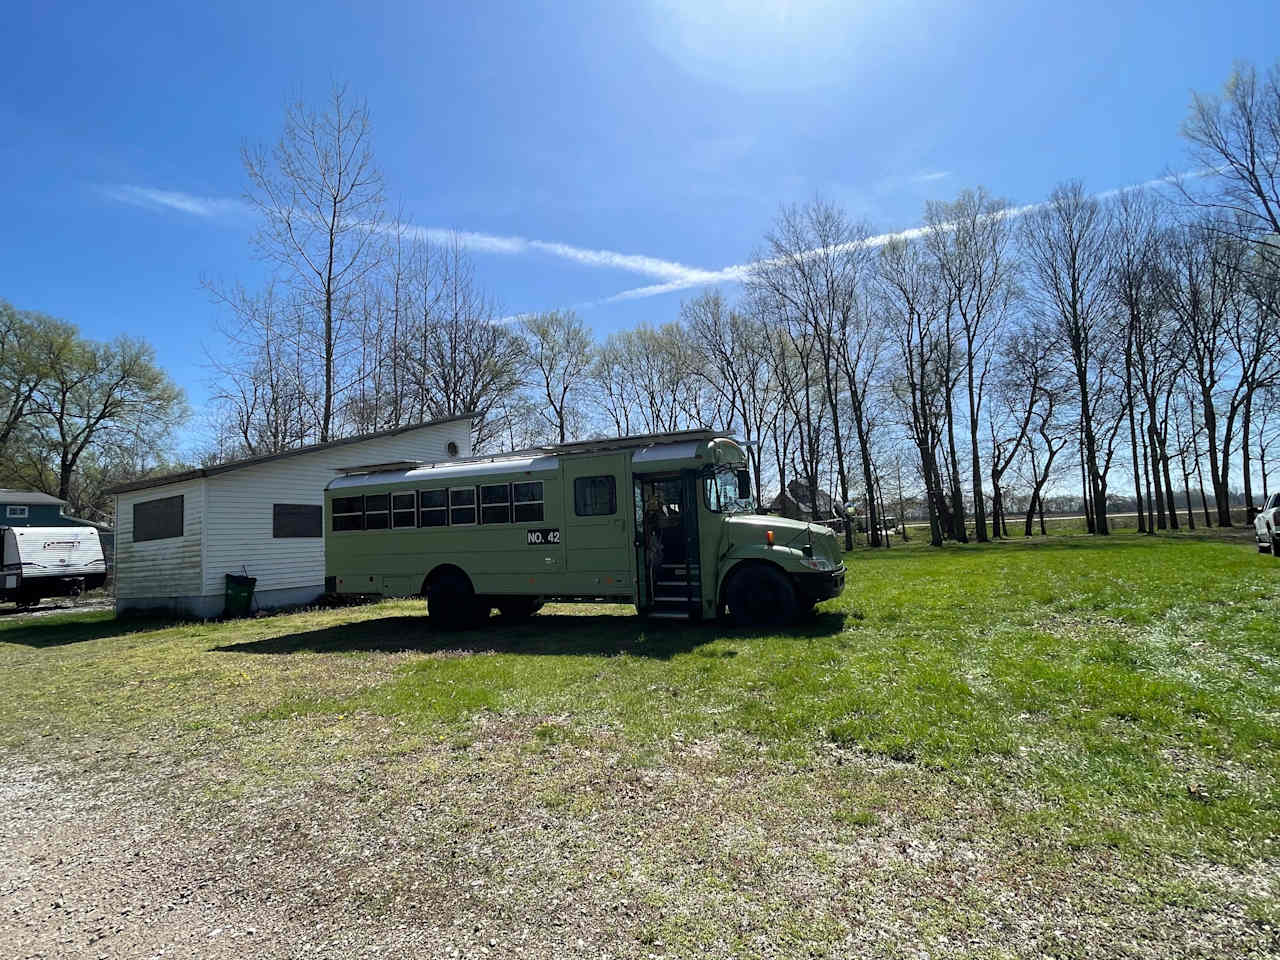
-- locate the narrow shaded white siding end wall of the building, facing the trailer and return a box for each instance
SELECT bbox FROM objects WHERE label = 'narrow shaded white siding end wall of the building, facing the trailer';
[115,479,207,599]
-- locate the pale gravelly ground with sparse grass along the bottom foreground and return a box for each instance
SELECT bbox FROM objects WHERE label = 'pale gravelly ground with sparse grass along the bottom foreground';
[0,717,1280,960]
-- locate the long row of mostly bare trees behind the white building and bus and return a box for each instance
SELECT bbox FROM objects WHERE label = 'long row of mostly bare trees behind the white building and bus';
[215,65,1280,544]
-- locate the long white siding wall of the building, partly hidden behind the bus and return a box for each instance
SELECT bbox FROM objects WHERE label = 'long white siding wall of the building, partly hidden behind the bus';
[202,420,471,596]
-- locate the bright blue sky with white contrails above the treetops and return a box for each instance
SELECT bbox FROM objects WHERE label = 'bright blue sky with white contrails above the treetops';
[0,0,1280,450]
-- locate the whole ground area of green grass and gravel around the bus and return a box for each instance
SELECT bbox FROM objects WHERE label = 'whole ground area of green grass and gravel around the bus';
[0,532,1280,957]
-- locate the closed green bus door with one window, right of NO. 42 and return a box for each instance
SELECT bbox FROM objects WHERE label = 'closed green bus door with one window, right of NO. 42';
[561,453,636,599]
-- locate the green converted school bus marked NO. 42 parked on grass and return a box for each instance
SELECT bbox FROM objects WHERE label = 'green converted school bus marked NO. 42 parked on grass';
[324,430,845,627]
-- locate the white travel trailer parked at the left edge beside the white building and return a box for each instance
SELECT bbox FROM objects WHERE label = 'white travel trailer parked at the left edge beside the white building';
[0,526,106,605]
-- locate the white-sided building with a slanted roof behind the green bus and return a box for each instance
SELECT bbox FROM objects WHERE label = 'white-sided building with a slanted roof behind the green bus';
[108,413,472,617]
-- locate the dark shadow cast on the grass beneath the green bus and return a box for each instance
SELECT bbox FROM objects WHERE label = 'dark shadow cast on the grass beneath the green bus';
[212,611,845,660]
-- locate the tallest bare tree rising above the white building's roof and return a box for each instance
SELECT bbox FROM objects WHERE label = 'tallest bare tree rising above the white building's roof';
[242,86,383,443]
